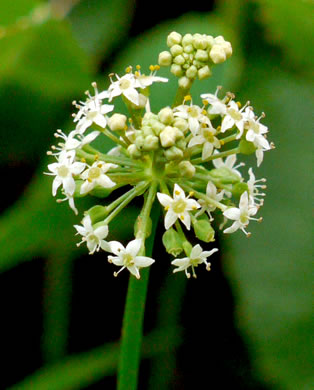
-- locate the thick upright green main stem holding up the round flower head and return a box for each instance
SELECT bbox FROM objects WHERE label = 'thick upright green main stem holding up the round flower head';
[118,183,159,390]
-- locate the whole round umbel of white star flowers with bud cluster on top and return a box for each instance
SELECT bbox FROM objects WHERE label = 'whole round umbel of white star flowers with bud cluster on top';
[48,32,273,278]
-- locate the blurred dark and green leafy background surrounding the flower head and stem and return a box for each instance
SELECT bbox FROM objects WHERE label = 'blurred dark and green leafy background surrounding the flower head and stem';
[0,0,314,390]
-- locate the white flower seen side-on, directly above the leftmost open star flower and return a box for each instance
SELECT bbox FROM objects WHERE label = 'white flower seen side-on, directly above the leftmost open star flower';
[52,130,100,155]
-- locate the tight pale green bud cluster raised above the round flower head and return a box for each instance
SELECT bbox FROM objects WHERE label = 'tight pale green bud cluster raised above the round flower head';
[158,32,232,88]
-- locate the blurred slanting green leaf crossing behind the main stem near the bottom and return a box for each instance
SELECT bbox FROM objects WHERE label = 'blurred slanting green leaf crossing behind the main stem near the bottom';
[10,327,182,390]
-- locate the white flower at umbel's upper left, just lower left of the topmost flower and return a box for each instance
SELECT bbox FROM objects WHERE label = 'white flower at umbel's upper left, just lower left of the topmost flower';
[74,83,114,134]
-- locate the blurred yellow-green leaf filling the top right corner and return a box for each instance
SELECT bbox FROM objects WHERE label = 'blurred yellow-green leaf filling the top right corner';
[255,0,314,75]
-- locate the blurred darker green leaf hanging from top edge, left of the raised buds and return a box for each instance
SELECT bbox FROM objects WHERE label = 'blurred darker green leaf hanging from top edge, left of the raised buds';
[69,0,135,60]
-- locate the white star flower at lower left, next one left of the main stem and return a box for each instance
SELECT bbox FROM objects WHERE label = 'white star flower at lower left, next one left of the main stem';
[74,215,109,255]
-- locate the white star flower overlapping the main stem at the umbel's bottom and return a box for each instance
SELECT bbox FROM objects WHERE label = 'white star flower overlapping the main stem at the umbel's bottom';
[108,239,155,279]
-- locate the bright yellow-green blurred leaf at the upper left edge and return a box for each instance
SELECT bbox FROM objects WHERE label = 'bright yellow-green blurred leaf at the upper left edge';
[0,21,90,98]
